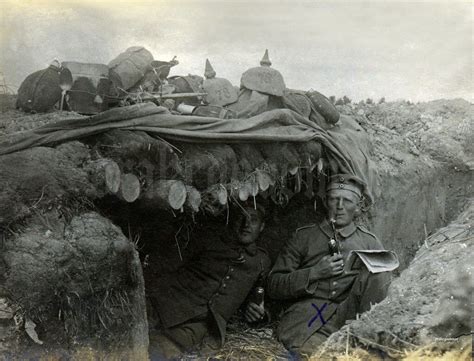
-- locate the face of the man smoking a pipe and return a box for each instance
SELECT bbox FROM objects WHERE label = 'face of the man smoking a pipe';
[326,189,360,228]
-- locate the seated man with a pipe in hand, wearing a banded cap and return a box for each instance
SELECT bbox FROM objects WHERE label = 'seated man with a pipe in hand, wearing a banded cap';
[268,175,390,357]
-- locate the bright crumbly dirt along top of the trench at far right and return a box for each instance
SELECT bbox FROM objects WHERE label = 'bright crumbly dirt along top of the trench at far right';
[339,99,474,170]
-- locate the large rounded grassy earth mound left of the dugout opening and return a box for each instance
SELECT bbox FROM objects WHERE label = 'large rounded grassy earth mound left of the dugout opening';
[0,210,148,356]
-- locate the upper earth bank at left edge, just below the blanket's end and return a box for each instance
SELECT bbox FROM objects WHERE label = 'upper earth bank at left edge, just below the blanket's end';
[0,142,95,227]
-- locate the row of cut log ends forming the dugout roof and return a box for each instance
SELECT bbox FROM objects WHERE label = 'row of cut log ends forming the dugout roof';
[88,130,323,214]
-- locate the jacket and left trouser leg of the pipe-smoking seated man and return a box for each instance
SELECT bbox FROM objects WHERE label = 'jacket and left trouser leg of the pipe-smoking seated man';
[267,220,384,346]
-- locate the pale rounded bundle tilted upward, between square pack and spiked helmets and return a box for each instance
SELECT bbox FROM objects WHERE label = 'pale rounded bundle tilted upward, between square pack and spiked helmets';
[109,46,153,90]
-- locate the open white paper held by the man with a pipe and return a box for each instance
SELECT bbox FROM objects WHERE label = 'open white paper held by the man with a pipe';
[344,250,400,273]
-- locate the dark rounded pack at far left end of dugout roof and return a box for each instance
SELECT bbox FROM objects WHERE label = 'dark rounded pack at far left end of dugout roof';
[16,61,61,113]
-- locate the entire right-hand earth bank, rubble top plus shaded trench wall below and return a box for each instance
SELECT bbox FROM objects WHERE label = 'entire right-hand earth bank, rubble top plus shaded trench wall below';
[338,99,474,269]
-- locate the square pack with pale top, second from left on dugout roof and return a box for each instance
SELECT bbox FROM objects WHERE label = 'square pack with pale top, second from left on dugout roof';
[62,61,112,114]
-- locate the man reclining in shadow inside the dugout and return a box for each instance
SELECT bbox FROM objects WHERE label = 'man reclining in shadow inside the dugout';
[150,201,270,358]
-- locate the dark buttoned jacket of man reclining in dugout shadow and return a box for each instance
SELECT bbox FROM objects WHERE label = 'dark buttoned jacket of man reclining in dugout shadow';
[153,238,270,341]
